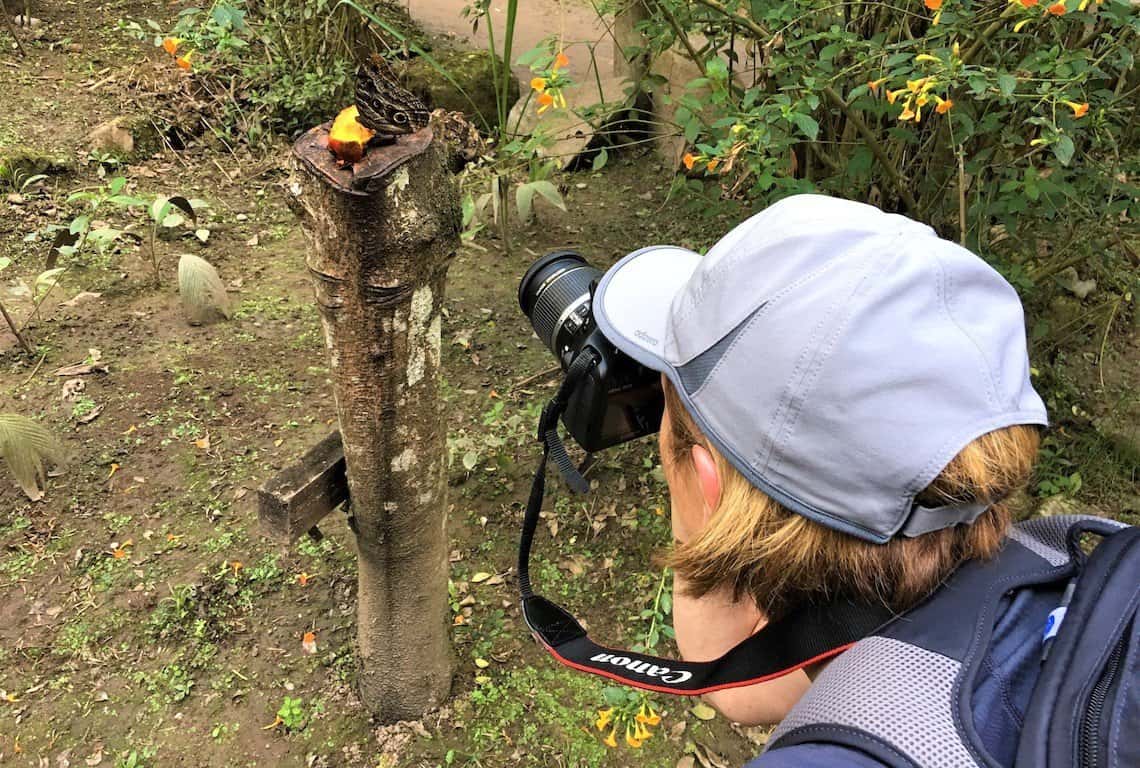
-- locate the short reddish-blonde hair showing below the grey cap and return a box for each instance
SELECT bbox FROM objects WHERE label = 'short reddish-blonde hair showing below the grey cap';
[665,382,1040,619]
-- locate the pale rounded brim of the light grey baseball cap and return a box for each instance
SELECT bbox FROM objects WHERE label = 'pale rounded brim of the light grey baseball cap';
[594,245,701,373]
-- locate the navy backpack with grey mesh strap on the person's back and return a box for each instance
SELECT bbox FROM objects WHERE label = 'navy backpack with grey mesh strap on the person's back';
[766,516,1140,768]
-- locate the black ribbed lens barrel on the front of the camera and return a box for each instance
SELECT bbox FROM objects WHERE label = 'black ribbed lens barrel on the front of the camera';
[519,251,602,359]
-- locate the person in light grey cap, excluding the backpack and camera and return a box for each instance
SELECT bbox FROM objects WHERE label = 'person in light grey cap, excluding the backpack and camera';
[594,195,1059,768]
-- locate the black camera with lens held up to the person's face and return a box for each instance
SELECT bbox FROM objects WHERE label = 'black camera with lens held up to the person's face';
[519,251,665,452]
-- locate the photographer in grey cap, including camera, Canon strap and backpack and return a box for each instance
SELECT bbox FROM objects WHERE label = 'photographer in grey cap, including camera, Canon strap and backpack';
[520,195,1140,768]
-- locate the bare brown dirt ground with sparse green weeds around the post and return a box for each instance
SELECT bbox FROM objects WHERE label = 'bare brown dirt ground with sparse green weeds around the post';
[0,0,1140,768]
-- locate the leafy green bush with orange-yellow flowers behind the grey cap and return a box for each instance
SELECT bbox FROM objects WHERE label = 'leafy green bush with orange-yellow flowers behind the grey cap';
[642,0,1140,275]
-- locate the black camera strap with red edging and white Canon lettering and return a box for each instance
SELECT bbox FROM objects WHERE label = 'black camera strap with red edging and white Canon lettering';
[519,346,895,696]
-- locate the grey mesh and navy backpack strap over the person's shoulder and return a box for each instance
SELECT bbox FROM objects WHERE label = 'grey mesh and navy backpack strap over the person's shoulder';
[767,515,1099,768]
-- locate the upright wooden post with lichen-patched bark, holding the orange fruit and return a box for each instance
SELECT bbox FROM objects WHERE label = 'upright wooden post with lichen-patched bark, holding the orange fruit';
[291,124,461,721]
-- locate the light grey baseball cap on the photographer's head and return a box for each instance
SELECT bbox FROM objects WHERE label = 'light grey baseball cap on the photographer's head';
[594,195,1048,542]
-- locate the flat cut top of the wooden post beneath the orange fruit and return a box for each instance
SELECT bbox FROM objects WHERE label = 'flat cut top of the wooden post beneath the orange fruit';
[293,122,432,197]
